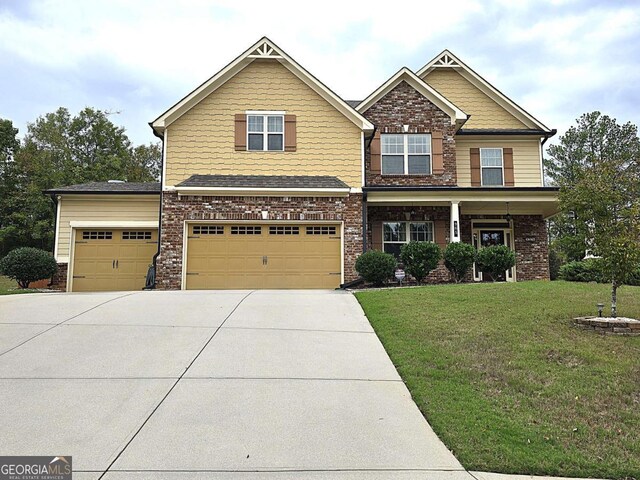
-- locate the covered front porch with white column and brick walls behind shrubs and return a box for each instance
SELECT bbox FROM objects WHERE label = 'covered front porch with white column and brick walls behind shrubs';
[364,186,558,283]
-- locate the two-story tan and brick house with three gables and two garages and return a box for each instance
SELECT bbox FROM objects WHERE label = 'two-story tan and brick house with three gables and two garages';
[48,38,557,291]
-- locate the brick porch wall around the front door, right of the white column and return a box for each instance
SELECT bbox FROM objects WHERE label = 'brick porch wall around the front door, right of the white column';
[460,215,550,281]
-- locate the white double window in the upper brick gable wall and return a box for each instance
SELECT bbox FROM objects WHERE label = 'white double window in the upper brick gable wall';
[380,133,431,175]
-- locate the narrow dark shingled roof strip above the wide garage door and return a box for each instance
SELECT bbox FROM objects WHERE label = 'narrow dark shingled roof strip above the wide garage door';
[176,175,349,188]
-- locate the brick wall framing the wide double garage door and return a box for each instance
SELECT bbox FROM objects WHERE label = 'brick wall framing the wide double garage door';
[156,192,362,290]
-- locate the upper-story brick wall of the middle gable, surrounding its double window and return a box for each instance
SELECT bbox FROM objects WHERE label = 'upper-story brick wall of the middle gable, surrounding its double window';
[364,82,457,185]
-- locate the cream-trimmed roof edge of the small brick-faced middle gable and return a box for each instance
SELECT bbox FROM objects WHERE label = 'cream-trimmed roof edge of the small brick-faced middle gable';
[356,67,469,125]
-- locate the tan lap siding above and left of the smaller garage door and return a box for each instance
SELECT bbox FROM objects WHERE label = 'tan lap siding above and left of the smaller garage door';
[57,195,160,261]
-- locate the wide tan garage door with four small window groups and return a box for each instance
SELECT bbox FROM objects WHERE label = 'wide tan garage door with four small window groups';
[186,224,342,290]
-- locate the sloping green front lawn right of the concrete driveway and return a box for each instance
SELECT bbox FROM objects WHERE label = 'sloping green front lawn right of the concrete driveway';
[356,282,640,479]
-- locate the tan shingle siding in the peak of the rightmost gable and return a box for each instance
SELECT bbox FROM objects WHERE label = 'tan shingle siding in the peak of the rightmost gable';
[425,68,527,128]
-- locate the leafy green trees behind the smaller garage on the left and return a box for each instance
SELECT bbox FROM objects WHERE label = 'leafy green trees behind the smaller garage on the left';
[0,108,161,255]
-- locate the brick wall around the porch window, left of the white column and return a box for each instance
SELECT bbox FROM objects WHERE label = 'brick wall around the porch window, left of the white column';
[367,206,451,283]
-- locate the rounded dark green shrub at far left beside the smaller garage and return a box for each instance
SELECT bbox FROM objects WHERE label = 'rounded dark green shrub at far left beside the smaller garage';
[0,247,58,288]
